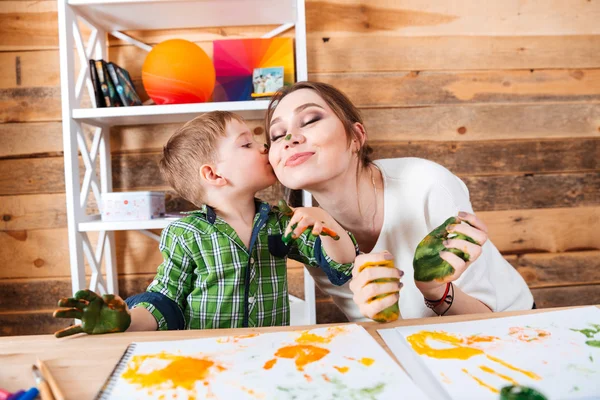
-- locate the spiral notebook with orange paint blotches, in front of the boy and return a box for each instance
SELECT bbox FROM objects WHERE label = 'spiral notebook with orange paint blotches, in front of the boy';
[96,325,426,400]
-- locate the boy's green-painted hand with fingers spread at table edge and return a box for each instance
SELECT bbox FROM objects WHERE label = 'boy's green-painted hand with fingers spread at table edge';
[53,289,131,338]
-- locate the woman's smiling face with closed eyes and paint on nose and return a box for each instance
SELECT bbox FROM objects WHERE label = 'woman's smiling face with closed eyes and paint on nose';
[267,89,352,190]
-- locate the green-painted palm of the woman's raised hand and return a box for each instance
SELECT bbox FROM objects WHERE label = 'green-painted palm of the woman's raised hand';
[413,217,478,282]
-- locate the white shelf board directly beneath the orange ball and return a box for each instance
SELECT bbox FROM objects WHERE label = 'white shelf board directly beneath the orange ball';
[72,100,269,126]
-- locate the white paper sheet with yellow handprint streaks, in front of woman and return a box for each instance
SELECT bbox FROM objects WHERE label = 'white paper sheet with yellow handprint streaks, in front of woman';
[379,307,600,400]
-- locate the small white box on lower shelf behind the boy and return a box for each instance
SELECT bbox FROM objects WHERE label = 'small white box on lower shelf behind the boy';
[102,192,165,221]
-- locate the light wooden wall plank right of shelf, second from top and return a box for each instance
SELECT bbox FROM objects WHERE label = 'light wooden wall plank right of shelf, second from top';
[307,32,600,73]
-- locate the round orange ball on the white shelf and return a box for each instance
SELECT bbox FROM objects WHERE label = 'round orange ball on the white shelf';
[142,39,215,104]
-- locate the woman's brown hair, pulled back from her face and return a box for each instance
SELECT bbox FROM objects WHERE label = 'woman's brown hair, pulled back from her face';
[265,81,373,167]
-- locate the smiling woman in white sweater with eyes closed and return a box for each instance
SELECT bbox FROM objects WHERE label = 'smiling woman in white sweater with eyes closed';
[266,82,533,321]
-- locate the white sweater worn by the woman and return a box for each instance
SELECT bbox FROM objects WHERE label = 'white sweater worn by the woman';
[308,158,533,321]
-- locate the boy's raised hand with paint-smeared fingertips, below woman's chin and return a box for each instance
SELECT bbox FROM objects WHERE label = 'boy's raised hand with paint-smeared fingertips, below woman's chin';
[278,200,340,244]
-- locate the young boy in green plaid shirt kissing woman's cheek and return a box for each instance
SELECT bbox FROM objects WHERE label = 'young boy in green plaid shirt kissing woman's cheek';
[54,111,356,337]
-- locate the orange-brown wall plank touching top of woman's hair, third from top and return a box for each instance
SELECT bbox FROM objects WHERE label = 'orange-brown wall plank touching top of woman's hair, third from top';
[311,70,600,107]
